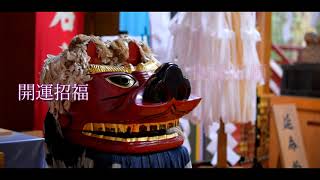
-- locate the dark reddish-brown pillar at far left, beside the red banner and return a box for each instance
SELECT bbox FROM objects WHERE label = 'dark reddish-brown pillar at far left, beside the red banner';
[0,12,36,131]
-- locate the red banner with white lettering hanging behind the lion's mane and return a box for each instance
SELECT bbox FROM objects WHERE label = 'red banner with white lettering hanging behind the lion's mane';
[33,12,84,130]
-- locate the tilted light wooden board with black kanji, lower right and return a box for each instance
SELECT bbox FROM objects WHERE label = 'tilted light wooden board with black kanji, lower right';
[272,104,308,168]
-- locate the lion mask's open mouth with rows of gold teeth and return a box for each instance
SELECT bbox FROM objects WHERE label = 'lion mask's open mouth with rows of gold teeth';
[82,119,179,142]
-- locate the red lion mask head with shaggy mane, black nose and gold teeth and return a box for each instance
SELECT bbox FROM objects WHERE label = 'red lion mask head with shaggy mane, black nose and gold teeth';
[41,35,200,154]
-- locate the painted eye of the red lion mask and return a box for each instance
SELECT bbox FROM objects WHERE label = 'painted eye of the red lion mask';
[106,74,136,88]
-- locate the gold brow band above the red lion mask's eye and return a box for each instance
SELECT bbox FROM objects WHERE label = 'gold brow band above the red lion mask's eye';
[88,61,160,74]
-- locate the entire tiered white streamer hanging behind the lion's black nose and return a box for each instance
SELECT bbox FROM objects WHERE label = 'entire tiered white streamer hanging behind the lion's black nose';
[168,12,263,134]
